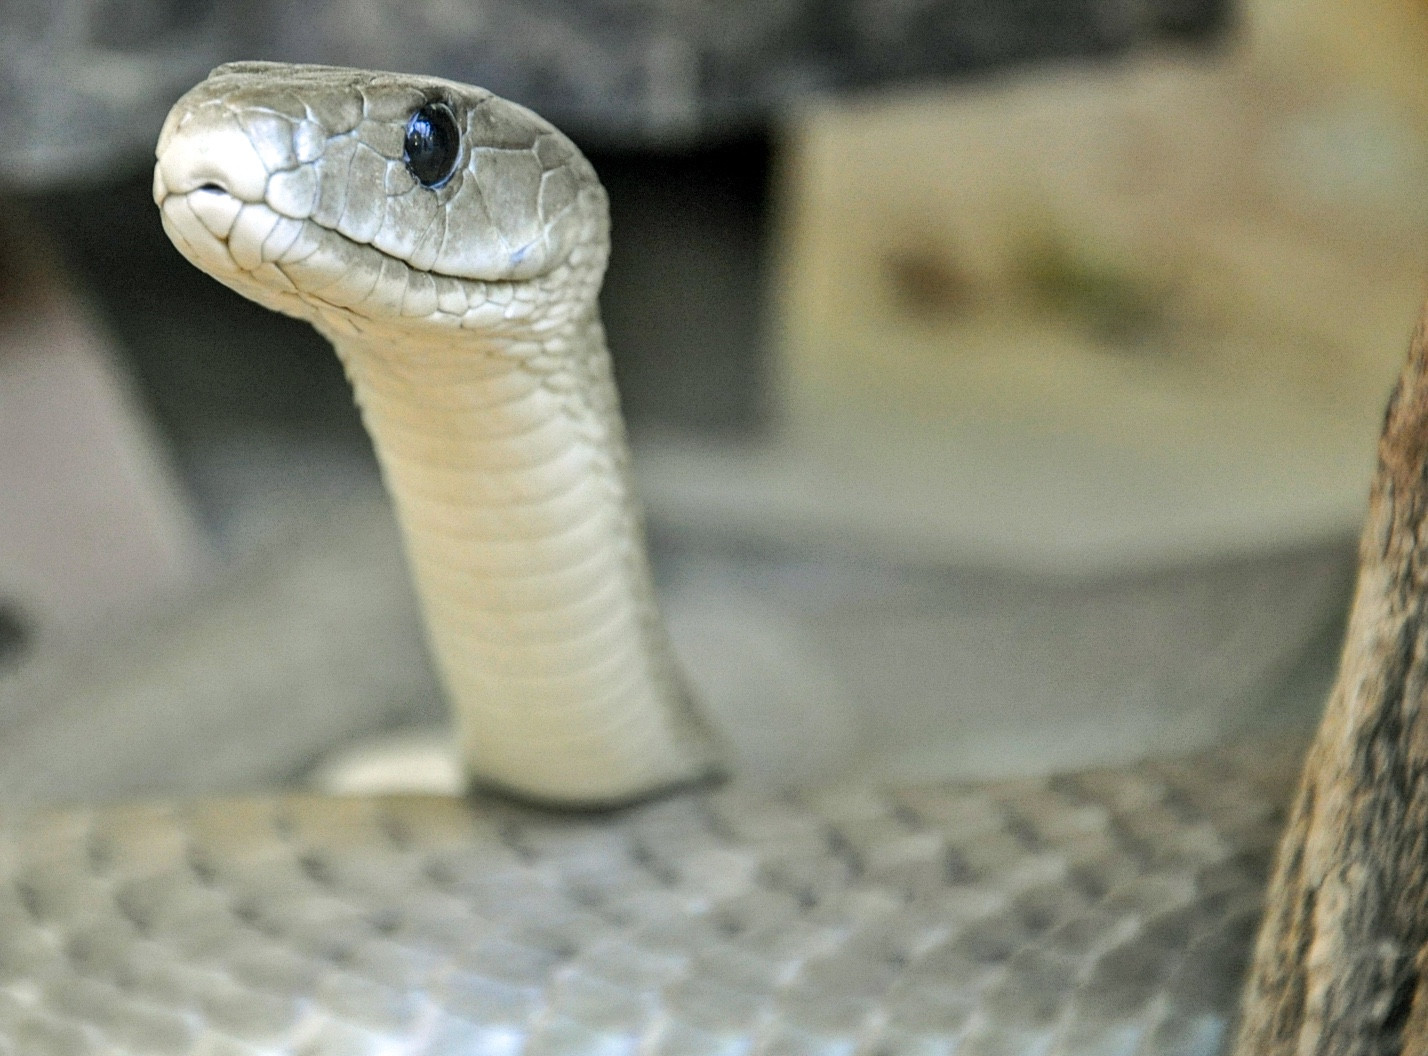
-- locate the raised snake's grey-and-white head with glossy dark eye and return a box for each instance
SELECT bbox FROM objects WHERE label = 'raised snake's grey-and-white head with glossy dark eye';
[154,63,608,334]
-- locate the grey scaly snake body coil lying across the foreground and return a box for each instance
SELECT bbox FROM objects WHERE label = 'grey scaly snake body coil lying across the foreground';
[0,743,1299,1056]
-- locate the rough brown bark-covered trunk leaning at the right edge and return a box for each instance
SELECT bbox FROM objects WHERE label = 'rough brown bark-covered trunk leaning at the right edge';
[1237,302,1428,1056]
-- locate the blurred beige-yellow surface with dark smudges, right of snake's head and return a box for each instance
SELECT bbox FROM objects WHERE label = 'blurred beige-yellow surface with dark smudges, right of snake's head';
[774,0,1428,569]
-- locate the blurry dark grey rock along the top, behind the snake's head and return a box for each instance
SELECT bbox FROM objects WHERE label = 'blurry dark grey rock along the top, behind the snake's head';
[0,0,1228,187]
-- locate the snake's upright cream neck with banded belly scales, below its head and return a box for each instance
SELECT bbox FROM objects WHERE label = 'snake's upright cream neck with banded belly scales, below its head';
[328,312,711,806]
